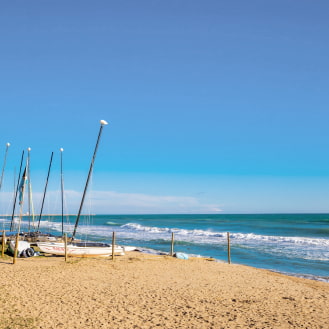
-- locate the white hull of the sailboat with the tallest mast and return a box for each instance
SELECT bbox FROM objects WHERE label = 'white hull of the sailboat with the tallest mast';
[37,242,125,257]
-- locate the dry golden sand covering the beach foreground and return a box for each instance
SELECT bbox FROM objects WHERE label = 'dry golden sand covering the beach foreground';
[0,252,329,329]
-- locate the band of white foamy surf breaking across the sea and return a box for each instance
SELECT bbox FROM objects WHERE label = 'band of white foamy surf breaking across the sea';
[12,220,329,261]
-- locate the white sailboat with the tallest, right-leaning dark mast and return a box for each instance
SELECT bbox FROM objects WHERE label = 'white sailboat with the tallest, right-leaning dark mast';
[37,120,125,257]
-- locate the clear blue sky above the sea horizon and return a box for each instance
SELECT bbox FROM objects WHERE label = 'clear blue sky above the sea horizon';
[0,0,329,214]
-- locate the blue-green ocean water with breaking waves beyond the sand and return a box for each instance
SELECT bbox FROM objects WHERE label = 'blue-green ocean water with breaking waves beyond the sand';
[0,214,329,282]
